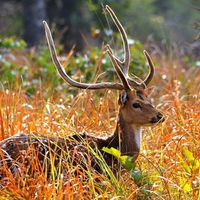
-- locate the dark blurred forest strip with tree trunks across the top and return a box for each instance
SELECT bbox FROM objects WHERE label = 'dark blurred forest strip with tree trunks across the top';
[0,0,199,51]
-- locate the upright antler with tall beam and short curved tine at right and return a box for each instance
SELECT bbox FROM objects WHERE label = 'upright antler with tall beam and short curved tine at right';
[106,5,154,89]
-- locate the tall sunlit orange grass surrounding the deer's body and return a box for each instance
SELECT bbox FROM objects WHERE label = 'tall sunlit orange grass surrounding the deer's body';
[0,48,200,199]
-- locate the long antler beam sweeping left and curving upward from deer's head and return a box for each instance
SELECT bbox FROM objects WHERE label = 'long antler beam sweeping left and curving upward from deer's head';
[43,21,124,90]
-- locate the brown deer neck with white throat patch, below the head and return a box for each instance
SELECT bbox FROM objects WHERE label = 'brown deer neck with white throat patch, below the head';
[107,112,142,159]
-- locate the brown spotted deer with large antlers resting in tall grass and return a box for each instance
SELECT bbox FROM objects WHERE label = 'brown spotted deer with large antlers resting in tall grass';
[0,5,164,180]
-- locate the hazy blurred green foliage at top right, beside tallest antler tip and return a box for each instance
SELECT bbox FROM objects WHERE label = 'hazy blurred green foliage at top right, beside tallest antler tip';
[88,0,200,47]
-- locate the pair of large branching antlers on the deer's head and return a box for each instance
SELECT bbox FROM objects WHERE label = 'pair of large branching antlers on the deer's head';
[43,6,154,92]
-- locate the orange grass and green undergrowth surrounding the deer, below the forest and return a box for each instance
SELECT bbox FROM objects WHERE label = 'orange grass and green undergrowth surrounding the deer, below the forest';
[0,38,200,199]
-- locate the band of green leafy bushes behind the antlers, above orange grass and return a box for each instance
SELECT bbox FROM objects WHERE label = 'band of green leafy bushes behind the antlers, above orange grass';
[0,33,148,95]
